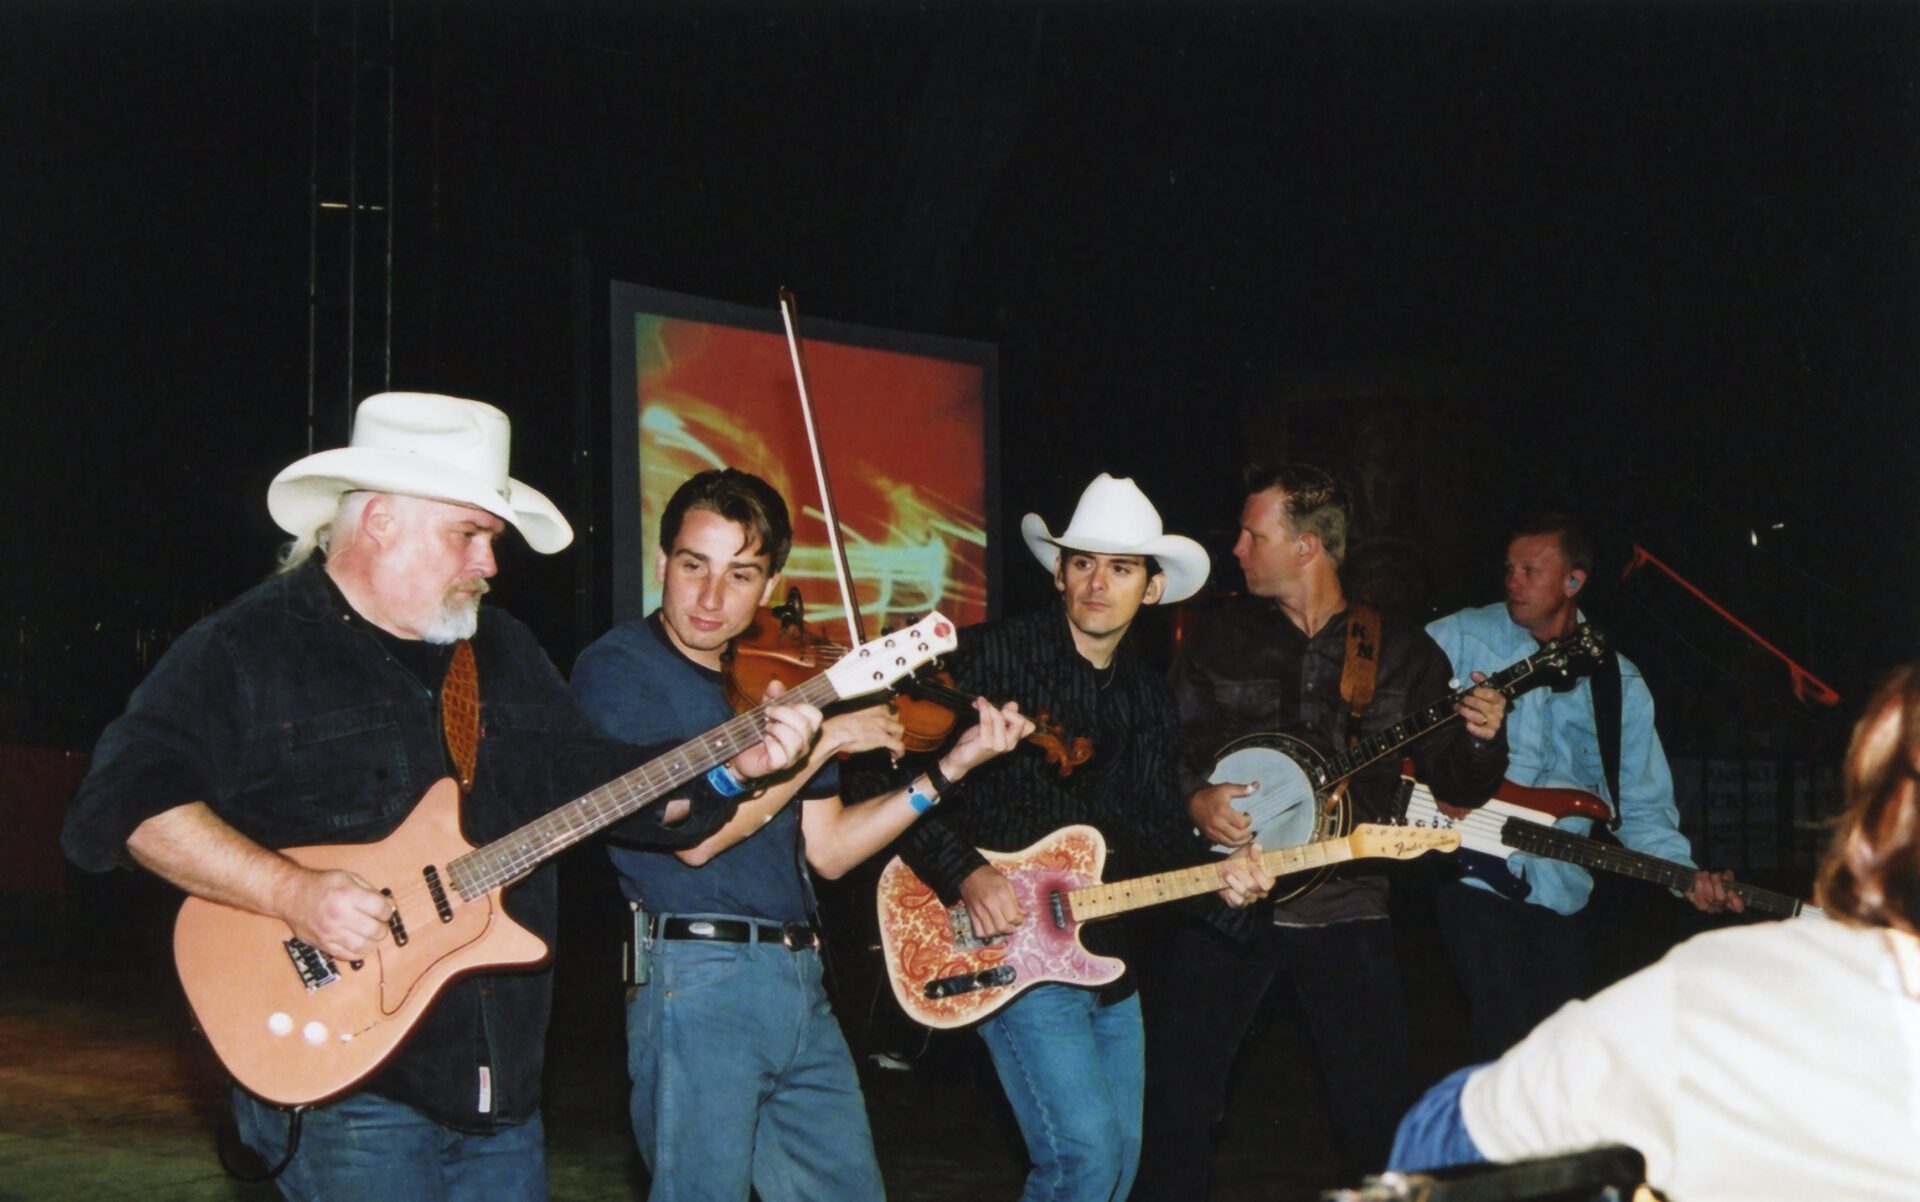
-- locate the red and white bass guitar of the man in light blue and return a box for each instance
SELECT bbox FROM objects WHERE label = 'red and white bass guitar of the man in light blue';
[1400,776,1826,918]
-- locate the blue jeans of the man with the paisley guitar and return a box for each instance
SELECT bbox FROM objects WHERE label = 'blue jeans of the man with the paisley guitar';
[979,985,1146,1202]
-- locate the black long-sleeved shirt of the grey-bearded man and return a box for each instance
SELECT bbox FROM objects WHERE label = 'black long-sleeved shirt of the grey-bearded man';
[61,563,733,1131]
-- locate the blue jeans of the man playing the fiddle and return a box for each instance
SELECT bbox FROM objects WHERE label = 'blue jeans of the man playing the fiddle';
[626,921,885,1202]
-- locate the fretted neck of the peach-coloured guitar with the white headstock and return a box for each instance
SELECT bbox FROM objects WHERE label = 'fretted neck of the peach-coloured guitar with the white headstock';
[447,676,841,901]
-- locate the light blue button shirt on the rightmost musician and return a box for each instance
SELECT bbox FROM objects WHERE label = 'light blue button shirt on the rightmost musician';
[1427,605,1693,914]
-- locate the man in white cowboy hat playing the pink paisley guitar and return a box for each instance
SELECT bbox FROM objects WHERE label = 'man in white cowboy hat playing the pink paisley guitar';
[902,474,1273,1200]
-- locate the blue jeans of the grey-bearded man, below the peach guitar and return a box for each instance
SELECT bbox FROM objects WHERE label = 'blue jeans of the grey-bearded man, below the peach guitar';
[232,1089,547,1202]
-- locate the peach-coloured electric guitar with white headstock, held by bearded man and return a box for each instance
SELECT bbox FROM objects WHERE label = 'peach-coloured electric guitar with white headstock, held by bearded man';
[173,613,954,1106]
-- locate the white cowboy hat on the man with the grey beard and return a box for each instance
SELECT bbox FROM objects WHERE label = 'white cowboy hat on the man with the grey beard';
[267,392,574,555]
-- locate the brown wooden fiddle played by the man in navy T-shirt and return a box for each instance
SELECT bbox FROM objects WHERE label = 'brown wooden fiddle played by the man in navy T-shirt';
[720,588,1092,776]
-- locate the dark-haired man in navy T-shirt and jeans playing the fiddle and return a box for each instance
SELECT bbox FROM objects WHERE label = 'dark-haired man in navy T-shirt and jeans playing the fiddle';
[572,469,1033,1202]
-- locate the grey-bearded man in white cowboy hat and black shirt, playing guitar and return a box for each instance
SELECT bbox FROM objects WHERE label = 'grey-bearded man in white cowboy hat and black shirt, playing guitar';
[63,394,820,1200]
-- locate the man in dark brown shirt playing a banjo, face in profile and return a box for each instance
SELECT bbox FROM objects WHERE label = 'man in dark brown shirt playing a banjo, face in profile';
[1135,463,1507,1202]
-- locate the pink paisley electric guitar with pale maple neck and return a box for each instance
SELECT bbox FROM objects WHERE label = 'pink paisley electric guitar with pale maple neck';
[879,826,1459,1027]
